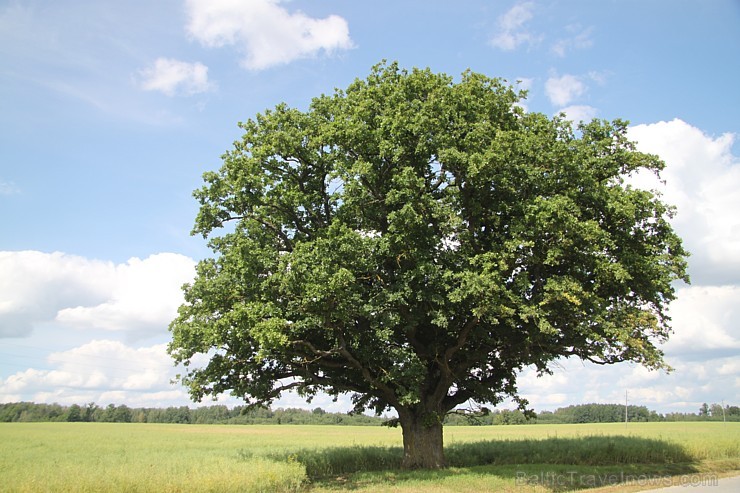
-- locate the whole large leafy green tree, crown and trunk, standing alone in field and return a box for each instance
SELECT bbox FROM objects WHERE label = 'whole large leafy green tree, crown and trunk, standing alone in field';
[169,63,688,467]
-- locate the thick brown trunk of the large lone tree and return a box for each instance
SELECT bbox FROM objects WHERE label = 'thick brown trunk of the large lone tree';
[398,411,445,469]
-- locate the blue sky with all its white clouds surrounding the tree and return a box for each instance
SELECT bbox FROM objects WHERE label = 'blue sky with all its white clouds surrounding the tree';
[0,0,740,413]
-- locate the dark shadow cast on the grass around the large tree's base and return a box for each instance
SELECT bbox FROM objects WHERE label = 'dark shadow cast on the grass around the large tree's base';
[246,436,696,491]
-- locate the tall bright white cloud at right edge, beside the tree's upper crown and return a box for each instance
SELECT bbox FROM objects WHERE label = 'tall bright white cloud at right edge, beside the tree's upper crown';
[629,119,740,285]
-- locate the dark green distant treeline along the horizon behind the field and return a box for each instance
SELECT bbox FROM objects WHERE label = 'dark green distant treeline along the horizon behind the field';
[0,402,740,426]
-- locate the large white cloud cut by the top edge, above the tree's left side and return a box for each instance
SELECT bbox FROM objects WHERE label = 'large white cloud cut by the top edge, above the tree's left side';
[187,0,353,70]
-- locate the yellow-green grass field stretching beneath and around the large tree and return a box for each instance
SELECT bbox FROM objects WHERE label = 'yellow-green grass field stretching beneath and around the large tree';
[0,423,740,493]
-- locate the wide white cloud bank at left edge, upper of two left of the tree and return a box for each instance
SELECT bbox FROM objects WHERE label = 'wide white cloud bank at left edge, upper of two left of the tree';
[0,251,195,337]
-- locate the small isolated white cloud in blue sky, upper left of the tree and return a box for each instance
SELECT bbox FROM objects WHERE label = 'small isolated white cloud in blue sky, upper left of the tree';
[139,58,214,96]
